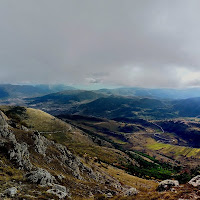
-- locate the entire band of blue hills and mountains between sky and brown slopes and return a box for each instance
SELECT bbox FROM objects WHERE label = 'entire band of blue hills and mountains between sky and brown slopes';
[0,84,200,119]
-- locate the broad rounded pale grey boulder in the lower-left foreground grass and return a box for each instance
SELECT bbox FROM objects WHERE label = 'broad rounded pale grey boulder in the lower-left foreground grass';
[26,168,55,185]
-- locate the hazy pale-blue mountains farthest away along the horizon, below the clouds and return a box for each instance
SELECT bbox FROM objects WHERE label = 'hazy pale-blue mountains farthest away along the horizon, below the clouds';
[0,84,200,99]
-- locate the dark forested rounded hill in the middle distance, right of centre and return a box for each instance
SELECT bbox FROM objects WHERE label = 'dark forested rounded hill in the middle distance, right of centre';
[68,96,176,119]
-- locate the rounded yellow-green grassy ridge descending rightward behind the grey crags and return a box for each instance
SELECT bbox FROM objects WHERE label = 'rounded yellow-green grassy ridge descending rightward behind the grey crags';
[0,106,133,167]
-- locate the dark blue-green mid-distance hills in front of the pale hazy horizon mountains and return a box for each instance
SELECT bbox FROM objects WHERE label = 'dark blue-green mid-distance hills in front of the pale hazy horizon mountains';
[27,90,200,119]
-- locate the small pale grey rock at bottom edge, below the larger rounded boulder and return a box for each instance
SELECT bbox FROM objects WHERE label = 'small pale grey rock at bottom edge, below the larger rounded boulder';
[47,184,71,199]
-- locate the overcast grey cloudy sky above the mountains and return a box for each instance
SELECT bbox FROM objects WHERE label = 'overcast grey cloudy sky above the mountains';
[0,0,200,88]
